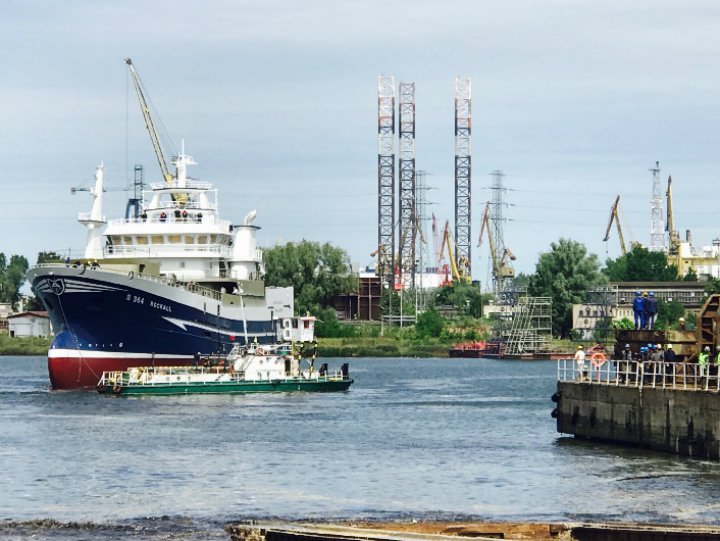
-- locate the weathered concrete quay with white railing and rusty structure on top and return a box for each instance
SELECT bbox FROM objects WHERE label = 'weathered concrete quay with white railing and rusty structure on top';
[552,294,720,460]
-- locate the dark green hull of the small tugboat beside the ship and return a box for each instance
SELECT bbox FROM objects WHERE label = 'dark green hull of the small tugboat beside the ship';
[98,378,353,396]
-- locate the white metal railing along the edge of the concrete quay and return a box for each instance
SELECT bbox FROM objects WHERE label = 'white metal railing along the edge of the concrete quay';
[557,359,720,393]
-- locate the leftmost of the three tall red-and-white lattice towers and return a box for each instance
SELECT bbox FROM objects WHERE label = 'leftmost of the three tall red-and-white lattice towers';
[377,75,395,282]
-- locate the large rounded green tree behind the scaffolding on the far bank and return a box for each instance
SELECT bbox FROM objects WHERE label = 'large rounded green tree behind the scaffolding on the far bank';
[528,238,606,337]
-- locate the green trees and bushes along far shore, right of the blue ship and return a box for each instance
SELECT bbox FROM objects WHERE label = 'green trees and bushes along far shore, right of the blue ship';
[265,238,700,337]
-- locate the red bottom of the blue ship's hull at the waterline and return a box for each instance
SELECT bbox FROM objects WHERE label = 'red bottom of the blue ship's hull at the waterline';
[48,357,193,389]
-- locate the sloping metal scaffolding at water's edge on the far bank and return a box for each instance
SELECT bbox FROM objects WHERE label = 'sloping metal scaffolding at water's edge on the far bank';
[505,297,552,355]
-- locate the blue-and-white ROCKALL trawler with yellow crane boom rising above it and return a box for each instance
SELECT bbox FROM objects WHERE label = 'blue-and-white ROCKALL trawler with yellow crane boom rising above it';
[27,59,314,389]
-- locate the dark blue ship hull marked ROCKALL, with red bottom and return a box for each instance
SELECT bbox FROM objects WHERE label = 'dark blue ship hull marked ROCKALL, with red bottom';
[32,270,276,389]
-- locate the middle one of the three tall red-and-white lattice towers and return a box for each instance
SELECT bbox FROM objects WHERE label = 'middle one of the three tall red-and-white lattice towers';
[398,83,417,289]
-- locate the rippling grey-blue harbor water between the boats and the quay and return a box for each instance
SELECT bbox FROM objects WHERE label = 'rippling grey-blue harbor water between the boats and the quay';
[0,357,720,539]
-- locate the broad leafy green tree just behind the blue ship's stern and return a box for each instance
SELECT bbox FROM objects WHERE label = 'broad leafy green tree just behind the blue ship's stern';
[263,240,358,314]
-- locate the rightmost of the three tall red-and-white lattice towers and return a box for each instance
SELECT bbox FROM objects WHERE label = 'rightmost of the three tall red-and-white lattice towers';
[455,77,472,277]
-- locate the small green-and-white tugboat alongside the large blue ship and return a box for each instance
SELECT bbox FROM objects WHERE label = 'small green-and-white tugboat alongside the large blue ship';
[97,343,353,395]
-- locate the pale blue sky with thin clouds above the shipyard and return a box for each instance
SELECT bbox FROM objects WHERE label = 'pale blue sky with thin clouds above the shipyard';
[0,0,720,283]
